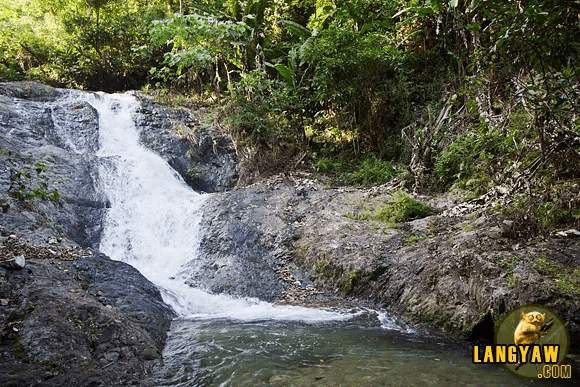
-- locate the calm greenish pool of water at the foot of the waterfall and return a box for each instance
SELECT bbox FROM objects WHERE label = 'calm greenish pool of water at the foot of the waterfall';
[154,316,530,387]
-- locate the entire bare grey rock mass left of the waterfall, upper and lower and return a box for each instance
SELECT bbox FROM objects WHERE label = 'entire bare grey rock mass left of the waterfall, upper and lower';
[0,82,187,386]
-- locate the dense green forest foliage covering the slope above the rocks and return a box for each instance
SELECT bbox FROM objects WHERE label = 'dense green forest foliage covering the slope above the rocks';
[0,0,580,230]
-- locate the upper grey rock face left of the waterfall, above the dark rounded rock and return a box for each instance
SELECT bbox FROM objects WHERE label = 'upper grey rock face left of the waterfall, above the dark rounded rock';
[0,82,107,246]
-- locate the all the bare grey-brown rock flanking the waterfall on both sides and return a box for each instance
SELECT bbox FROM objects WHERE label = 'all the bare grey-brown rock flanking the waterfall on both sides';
[0,82,580,386]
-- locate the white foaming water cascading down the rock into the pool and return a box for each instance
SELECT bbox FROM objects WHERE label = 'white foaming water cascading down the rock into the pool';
[80,93,349,322]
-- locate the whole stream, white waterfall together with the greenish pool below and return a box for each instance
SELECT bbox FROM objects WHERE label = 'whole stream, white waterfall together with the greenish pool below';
[67,93,572,387]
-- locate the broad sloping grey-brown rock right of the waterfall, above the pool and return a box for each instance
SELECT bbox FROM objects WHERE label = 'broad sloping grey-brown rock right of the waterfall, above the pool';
[193,175,580,348]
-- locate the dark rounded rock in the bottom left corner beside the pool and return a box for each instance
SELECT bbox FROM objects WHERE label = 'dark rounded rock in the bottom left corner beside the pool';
[0,250,175,387]
